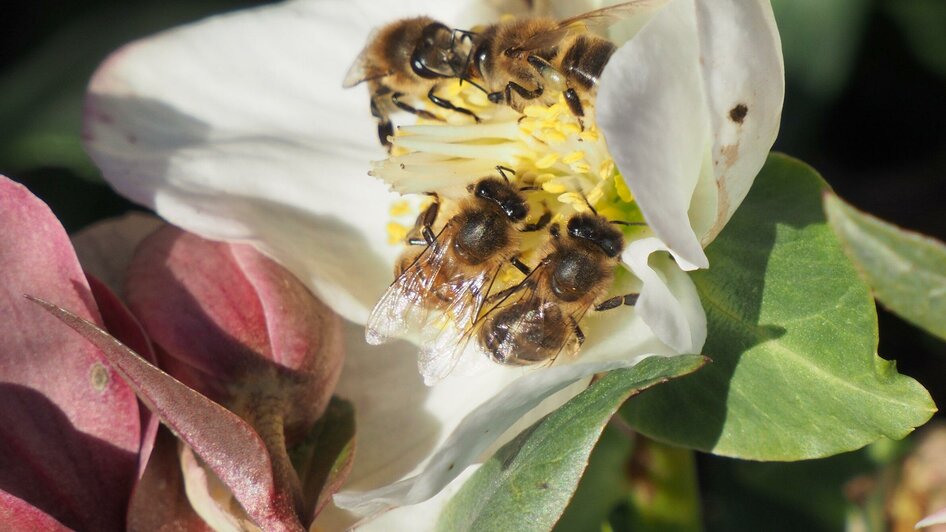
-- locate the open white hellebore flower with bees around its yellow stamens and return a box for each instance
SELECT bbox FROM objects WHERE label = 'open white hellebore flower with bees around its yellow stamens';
[84,0,784,527]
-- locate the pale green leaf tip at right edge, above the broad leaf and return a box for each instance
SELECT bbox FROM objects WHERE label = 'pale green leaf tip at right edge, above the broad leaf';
[824,194,946,339]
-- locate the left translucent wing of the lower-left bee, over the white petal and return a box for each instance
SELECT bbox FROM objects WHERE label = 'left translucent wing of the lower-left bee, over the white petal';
[365,232,449,345]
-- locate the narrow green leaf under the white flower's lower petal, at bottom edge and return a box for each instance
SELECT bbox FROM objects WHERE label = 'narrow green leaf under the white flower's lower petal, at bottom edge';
[437,355,706,531]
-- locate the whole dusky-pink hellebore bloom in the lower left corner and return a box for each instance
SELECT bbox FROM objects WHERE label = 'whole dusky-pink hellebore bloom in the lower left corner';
[0,176,350,530]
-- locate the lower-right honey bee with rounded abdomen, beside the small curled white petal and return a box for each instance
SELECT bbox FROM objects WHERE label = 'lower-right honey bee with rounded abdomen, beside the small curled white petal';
[477,213,637,366]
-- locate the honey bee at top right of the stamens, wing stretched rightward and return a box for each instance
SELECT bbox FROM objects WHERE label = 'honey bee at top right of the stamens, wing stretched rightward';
[470,0,652,120]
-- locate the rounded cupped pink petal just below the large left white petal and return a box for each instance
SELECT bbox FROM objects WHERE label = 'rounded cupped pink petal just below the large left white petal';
[127,227,343,438]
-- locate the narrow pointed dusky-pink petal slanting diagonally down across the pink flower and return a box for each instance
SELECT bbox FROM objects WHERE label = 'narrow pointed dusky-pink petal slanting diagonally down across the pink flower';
[33,299,302,531]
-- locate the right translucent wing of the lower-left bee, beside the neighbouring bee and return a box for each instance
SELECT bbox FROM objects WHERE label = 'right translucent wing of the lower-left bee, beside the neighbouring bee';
[417,271,496,386]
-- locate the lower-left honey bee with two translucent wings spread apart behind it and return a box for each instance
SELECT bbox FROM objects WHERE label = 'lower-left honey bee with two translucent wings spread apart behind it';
[365,167,550,383]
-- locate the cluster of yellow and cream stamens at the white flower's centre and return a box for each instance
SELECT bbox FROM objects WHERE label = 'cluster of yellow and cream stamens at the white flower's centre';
[371,80,646,288]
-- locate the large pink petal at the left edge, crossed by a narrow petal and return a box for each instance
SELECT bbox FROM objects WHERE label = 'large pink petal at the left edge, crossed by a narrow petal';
[0,176,140,530]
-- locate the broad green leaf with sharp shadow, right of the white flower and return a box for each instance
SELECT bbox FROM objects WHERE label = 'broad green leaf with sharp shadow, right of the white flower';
[624,155,935,460]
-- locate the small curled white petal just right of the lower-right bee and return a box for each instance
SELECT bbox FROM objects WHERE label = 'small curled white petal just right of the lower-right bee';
[622,237,706,354]
